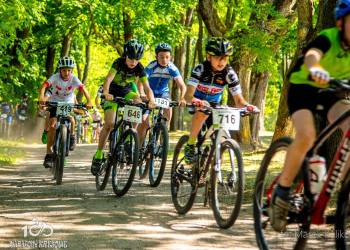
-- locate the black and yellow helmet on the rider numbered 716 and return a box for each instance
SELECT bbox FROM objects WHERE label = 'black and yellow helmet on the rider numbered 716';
[205,37,233,56]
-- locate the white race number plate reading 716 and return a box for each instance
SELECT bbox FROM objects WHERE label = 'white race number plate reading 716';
[213,109,241,130]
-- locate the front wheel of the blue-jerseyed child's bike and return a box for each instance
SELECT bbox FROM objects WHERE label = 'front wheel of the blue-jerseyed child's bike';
[148,122,169,187]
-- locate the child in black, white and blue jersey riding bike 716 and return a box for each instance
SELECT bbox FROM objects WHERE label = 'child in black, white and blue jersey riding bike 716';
[185,37,257,164]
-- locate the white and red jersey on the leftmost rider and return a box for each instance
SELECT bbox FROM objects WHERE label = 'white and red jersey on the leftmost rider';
[45,73,84,103]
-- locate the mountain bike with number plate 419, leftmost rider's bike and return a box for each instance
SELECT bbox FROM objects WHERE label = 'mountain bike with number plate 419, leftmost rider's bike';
[41,102,87,185]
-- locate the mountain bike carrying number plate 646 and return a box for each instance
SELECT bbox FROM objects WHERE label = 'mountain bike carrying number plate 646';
[95,95,144,197]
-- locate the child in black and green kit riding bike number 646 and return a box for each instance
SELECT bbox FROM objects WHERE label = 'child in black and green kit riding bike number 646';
[91,39,155,175]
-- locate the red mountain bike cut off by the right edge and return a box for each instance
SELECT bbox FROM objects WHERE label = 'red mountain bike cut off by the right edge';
[253,80,350,249]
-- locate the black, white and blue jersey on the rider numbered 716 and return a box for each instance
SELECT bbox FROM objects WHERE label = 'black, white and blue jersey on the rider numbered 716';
[188,61,242,103]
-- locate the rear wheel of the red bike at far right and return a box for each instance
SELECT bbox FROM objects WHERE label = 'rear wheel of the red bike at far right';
[253,137,310,250]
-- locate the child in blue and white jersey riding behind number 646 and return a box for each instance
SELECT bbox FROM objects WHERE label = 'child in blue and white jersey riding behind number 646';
[138,43,186,144]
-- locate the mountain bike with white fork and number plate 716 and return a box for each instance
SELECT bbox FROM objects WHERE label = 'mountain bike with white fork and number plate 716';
[170,106,258,228]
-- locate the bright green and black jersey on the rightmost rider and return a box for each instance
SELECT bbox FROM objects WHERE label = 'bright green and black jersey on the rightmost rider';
[289,28,350,88]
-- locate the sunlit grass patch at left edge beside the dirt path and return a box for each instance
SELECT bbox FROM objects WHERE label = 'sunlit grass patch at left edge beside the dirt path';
[0,140,25,166]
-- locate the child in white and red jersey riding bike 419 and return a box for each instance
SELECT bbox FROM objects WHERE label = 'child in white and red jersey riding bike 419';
[39,56,92,168]
